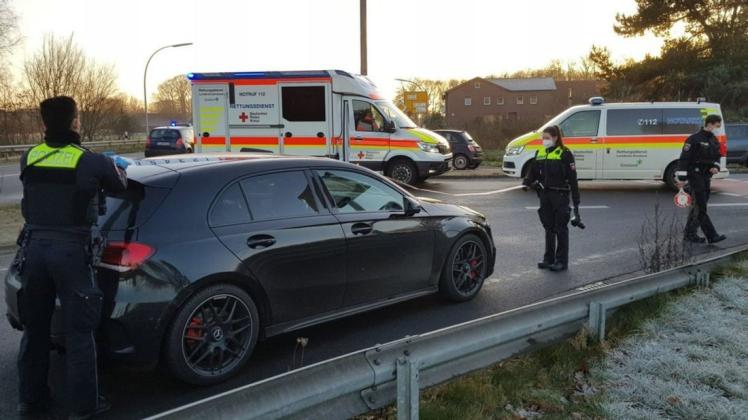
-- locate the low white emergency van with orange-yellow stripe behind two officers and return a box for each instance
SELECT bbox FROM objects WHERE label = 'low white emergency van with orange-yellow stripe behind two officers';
[502,97,729,188]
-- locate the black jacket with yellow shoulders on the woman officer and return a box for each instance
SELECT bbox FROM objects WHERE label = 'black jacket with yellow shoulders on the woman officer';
[523,146,580,206]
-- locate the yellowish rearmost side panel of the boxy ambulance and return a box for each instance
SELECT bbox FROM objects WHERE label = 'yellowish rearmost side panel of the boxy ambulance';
[192,83,230,153]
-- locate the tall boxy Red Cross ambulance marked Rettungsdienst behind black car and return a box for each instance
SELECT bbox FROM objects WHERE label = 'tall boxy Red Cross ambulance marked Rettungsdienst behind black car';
[187,70,452,184]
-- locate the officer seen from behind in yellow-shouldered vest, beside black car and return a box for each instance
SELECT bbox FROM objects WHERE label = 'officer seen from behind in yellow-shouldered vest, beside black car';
[16,96,127,418]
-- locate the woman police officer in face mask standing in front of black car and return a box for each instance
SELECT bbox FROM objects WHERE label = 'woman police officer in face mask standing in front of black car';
[523,126,583,271]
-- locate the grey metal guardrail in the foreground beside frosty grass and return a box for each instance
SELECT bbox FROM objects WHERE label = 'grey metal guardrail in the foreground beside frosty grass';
[149,246,748,420]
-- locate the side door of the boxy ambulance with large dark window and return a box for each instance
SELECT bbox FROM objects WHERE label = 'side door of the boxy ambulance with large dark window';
[278,82,333,156]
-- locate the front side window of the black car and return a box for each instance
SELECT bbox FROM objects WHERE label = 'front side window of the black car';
[317,170,405,213]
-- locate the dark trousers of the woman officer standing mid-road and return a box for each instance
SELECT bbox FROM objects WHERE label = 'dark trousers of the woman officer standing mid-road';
[538,190,571,265]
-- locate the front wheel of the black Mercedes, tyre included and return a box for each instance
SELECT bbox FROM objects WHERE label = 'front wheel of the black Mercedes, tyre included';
[439,233,488,302]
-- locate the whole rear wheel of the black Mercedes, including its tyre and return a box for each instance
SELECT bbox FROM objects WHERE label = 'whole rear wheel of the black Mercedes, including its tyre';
[164,284,260,385]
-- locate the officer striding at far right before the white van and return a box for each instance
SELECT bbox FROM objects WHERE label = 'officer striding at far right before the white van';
[677,115,727,244]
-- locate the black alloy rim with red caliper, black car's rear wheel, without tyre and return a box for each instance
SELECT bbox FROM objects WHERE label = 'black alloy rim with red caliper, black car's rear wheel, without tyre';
[182,294,256,376]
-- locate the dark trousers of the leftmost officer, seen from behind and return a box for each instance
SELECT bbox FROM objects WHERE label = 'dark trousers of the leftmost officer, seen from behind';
[18,236,102,412]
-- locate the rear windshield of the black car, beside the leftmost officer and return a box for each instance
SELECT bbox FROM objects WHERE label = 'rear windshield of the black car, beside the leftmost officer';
[99,180,170,231]
